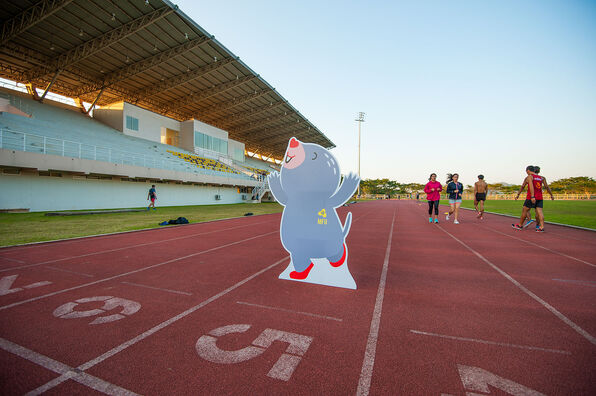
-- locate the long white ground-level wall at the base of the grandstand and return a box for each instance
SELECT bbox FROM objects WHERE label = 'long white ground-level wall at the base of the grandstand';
[0,174,250,212]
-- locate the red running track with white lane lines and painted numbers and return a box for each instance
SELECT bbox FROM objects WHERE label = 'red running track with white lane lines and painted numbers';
[0,201,596,395]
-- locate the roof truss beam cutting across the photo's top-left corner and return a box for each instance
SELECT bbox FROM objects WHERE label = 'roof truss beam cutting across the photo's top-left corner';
[0,0,72,46]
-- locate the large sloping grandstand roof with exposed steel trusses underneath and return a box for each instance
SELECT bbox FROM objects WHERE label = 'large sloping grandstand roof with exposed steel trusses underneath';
[0,0,334,159]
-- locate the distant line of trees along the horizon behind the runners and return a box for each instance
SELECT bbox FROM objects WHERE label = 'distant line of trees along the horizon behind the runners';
[360,176,596,195]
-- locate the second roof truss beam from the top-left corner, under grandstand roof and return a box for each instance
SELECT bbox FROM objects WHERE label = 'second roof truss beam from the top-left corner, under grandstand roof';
[25,6,174,81]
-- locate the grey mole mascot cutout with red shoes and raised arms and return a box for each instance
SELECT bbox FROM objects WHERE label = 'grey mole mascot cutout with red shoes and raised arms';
[268,138,360,289]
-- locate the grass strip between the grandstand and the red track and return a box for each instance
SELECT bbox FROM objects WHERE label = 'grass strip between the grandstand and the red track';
[0,203,283,246]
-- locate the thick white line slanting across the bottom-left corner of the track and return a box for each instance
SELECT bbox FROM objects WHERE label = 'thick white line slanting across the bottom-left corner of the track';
[0,338,136,395]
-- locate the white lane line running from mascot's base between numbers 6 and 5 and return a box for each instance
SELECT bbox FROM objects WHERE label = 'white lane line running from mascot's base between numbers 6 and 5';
[33,256,290,390]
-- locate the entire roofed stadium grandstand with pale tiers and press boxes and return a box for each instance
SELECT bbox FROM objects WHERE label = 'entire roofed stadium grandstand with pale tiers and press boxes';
[0,0,334,211]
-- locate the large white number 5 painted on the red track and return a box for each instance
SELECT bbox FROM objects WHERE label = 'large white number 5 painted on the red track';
[196,324,312,381]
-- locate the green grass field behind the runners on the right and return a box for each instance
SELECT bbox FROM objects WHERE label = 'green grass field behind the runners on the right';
[441,198,596,229]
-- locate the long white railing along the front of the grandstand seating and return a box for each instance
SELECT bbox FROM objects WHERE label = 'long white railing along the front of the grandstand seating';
[0,128,254,179]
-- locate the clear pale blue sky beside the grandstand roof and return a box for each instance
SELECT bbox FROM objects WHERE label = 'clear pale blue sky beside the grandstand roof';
[175,0,596,184]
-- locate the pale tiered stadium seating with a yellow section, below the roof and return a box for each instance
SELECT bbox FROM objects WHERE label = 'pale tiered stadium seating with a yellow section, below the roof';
[0,92,250,179]
